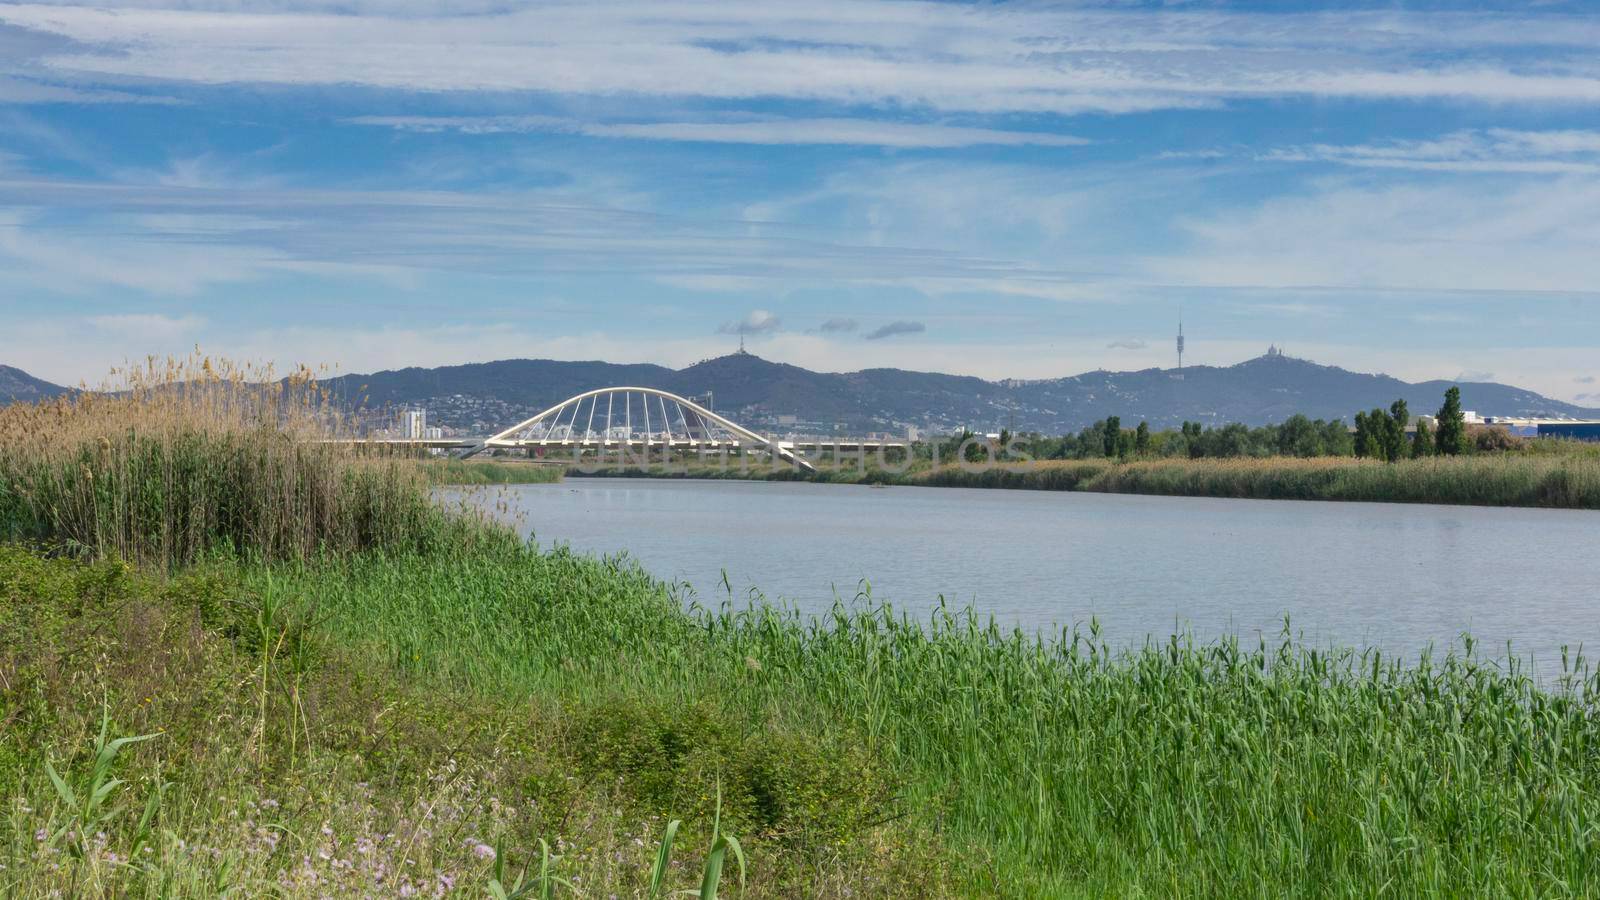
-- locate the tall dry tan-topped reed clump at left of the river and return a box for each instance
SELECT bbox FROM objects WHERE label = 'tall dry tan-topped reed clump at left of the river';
[0,354,442,565]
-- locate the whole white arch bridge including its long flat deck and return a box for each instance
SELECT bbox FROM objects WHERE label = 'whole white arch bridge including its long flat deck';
[370,388,906,471]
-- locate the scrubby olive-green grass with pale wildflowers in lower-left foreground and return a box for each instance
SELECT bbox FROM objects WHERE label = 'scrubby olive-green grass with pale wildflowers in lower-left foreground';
[0,544,949,897]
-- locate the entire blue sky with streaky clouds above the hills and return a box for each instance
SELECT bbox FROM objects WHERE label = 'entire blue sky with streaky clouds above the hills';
[0,0,1600,398]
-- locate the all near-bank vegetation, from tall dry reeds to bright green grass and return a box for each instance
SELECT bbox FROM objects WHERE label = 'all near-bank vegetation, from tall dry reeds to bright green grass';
[0,361,1600,897]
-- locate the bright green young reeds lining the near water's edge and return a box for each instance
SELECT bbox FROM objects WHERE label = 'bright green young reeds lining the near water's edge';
[256,534,1600,895]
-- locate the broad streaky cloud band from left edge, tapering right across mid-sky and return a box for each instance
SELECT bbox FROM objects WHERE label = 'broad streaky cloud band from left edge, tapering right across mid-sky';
[0,171,1062,295]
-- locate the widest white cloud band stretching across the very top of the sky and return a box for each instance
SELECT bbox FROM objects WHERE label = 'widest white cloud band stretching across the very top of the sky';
[0,0,1600,114]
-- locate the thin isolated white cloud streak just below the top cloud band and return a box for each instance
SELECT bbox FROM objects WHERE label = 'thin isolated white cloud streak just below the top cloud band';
[350,115,1088,149]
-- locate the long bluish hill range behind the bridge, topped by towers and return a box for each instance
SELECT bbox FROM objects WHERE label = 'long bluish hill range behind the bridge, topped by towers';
[330,352,1600,434]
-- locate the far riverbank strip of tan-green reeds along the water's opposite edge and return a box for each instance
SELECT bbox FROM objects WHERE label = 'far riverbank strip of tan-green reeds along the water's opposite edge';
[568,453,1600,509]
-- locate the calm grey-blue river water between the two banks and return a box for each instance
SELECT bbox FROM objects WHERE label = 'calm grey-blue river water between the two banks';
[448,479,1600,662]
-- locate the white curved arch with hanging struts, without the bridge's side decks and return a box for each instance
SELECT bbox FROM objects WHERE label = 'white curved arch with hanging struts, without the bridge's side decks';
[462,386,814,471]
